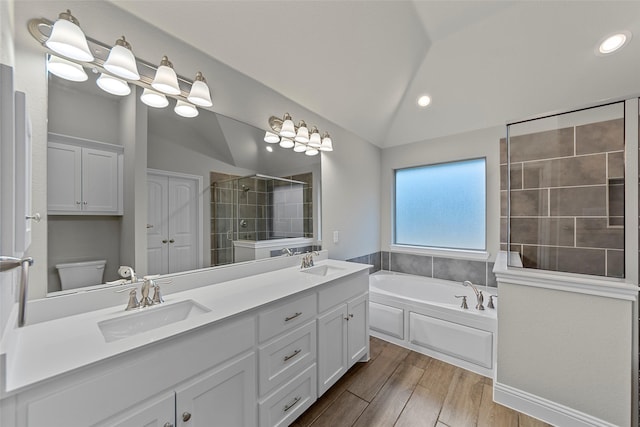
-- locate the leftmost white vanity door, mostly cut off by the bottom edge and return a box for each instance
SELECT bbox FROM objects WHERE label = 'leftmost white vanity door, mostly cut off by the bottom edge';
[104,393,176,427]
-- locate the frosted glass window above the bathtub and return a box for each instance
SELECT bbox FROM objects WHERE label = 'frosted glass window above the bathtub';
[395,158,486,250]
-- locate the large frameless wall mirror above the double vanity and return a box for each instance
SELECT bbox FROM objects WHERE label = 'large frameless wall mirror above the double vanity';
[47,70,320,294]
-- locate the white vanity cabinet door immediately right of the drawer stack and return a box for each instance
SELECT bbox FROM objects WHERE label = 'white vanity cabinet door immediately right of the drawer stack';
[318,304,348,397]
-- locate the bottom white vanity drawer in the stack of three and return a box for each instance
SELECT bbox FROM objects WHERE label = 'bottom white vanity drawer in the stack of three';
[259,363,317,427]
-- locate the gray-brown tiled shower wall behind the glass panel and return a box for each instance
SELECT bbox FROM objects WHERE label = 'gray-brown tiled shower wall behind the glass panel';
[500,119,624,277]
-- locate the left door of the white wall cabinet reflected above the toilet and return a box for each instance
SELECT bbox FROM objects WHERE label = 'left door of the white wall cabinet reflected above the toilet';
[47,142,82,212]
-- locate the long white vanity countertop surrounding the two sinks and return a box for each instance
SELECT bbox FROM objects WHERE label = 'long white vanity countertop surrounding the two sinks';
[2,260,369,394]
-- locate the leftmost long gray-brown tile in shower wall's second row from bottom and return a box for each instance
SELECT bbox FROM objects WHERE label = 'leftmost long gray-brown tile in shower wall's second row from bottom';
[511,218,574,246]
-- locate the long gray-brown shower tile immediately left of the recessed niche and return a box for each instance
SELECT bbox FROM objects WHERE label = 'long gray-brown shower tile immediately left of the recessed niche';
[549,185,607,216]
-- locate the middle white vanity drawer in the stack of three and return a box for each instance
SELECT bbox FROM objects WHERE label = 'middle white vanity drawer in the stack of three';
[258,321,316,396]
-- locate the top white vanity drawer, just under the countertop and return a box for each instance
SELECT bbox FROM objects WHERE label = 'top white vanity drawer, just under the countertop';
[258,293,316,342]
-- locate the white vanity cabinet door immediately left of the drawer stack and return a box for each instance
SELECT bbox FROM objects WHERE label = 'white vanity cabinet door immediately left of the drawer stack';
[176,353,258,427]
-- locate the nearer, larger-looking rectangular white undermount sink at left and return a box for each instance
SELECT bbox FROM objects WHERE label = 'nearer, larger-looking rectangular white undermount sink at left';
[98,300,211,342]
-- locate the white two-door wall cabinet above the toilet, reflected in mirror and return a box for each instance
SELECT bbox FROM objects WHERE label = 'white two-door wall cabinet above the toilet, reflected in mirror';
[47,136,122,215]
